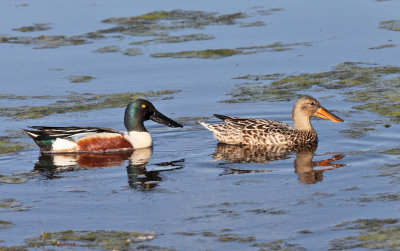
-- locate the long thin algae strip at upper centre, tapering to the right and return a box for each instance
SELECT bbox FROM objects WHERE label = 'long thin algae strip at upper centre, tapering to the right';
[151,42,311,59]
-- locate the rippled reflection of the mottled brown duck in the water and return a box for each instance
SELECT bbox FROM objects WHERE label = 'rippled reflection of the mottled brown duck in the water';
[213,144,344,184]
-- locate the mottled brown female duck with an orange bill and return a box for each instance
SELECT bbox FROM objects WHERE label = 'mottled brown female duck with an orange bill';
[200,96,343,145]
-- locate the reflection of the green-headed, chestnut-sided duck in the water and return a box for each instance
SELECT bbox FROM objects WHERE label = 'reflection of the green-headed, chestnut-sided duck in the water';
[34,148,184,190]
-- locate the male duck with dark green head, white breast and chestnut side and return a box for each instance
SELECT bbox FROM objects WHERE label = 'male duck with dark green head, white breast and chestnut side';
[24,99,182,153]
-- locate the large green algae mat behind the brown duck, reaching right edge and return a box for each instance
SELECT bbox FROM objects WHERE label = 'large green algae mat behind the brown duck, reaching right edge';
[222,62,400,118]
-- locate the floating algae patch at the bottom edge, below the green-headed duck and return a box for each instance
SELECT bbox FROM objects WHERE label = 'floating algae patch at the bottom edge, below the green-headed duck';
[25,230,157,250]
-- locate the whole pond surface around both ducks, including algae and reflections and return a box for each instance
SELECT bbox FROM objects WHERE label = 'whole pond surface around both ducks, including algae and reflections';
[0,0,400,250]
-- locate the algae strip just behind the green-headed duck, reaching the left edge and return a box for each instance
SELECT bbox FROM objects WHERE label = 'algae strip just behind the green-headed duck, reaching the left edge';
[0,90,179,119]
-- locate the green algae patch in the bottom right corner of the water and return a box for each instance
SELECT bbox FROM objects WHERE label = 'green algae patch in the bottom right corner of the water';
[329,218,400,250]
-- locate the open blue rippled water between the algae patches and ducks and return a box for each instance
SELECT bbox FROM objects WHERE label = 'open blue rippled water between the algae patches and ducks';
[0,0,400,250]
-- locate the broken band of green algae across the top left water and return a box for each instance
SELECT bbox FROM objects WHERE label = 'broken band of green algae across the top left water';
[0,9,280,52]
